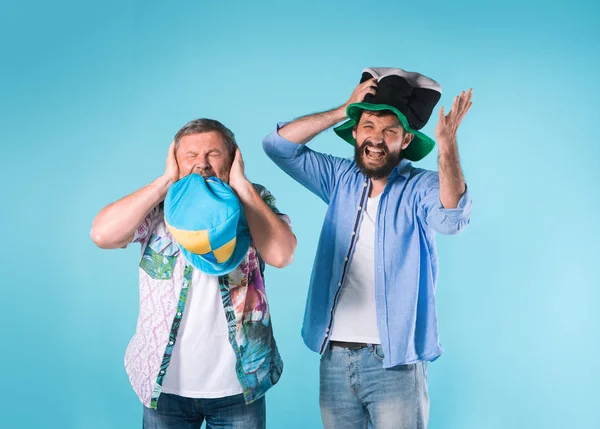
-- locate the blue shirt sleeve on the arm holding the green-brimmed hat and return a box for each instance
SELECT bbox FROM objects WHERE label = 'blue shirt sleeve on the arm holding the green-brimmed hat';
[263,122,346,204]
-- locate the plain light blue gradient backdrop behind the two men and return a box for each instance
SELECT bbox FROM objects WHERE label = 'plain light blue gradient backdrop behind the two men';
[0,0,600,429]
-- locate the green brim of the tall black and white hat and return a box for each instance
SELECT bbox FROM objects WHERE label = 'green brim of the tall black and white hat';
[333,103,435,161]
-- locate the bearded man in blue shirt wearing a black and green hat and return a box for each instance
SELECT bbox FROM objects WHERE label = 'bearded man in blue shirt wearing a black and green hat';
[263,68,471,429]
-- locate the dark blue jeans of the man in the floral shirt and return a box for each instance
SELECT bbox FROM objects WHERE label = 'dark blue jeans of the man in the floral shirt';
[143,393,266,429]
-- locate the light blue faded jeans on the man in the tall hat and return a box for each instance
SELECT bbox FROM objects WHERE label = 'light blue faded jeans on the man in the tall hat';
[320,345,429,429]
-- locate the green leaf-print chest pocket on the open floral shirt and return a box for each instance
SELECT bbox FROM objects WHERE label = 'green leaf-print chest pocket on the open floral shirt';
[140,234,179,280]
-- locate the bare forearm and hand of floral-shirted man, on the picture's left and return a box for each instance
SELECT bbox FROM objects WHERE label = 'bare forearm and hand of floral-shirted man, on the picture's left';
[90,140,179,249]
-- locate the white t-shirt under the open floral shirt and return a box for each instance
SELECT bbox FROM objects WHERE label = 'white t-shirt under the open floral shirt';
[162,269,243,399]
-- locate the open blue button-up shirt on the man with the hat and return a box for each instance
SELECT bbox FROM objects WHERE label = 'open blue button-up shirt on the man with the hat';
[263,123,471,368]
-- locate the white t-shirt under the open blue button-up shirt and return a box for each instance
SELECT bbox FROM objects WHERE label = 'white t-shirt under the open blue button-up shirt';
[331,194,381,344]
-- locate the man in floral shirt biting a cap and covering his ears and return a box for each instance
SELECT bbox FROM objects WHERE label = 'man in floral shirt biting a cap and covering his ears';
[91,119,296,429]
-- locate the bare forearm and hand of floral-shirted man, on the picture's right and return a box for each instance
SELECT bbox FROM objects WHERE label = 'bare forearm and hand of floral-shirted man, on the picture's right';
[230,149,296,268]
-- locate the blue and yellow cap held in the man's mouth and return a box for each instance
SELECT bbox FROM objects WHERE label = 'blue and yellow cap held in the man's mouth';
[164,174,250,276]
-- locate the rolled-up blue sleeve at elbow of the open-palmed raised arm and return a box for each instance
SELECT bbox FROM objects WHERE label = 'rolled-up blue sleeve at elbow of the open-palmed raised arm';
[419,173,472,235]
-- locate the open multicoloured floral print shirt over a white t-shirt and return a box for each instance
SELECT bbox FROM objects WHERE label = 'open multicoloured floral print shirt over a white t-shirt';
[125,184,291,408]
